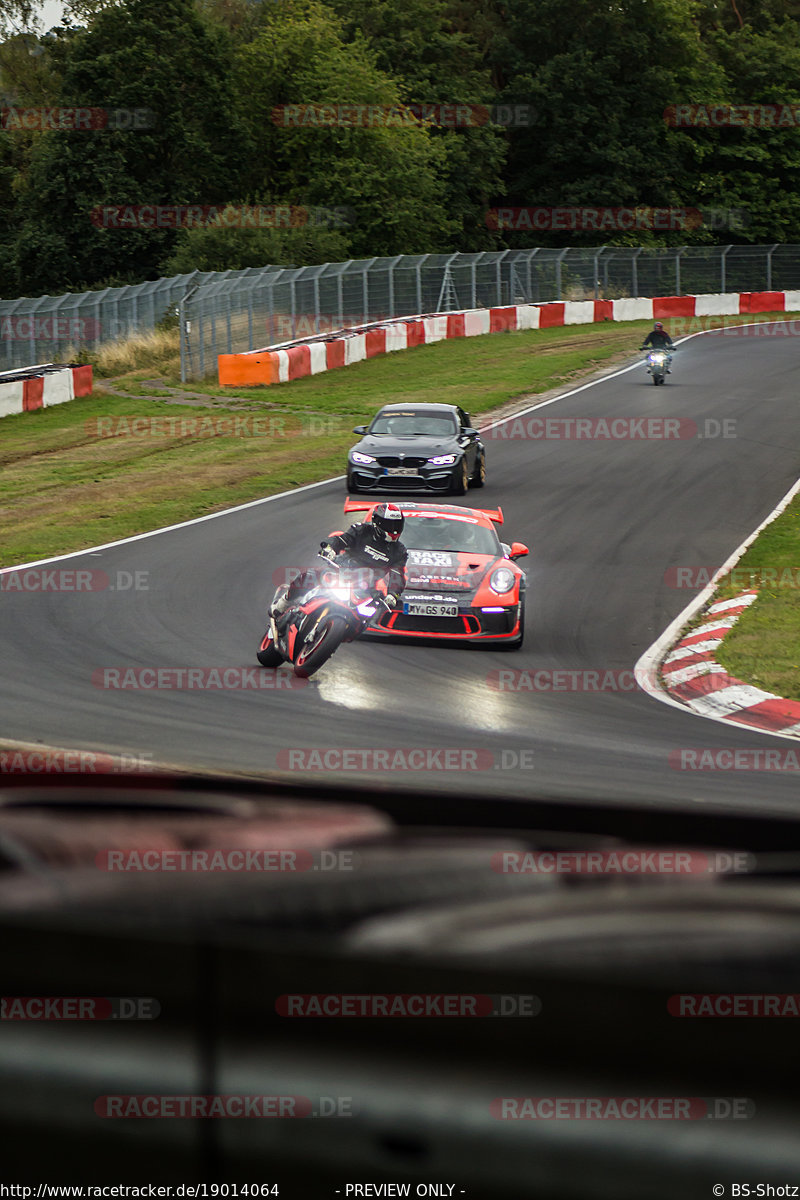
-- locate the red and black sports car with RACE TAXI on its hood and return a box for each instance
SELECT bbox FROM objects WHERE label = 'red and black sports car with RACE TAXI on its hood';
[344,498,528,648]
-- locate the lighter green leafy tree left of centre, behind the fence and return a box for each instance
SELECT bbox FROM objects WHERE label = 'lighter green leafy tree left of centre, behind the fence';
[231,0,457,257]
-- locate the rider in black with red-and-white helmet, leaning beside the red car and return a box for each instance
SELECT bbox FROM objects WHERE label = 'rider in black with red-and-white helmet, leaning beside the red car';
[270,504,408,617]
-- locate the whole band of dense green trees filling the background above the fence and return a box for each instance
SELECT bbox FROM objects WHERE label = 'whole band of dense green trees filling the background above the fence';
[0,0,800,296]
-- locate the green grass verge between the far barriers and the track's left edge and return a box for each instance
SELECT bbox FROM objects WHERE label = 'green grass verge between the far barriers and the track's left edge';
[0,322,646,566]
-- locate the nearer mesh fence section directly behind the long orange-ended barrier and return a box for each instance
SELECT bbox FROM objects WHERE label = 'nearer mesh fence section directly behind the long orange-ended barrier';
[181,245,800,379]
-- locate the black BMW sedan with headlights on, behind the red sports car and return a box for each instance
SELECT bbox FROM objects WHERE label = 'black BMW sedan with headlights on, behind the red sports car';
[347,404,486,496]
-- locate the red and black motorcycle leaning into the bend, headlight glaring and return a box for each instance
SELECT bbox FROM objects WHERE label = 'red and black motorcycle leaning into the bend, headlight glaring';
[255,544,392,679]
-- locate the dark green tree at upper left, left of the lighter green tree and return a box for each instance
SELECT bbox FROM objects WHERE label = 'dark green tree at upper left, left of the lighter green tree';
[16,0,246,290]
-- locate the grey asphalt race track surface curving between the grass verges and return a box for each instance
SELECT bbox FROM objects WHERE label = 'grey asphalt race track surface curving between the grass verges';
[0,326,800,811]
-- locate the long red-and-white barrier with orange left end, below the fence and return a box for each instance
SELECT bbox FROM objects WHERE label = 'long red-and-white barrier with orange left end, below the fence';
[218,292,800,388]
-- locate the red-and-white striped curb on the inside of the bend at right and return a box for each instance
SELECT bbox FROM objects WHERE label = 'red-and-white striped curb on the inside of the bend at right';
[661,592,800,737]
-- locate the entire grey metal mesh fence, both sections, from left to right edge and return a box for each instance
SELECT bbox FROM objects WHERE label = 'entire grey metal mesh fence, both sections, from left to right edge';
[6,245,800,379]
